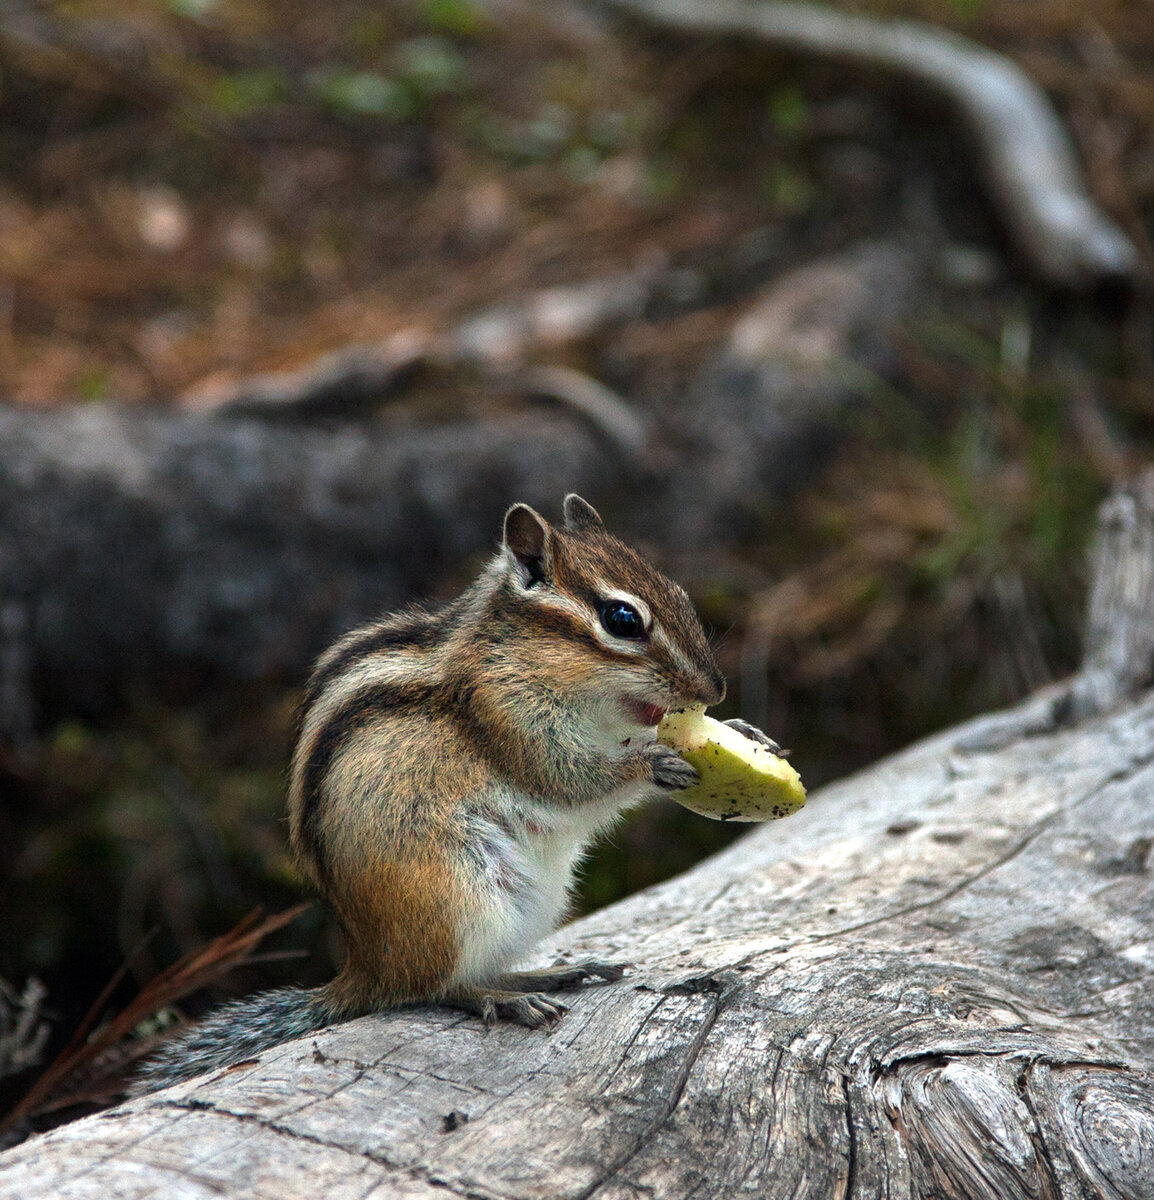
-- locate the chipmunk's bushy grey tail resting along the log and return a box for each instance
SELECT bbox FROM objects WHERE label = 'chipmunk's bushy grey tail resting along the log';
[132,988,340,1096]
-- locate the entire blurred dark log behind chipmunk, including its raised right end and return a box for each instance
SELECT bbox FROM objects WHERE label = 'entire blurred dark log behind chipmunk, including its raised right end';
[0,245,916,738]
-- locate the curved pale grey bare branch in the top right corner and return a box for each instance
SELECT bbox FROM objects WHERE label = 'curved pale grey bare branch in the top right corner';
[601,0,1143,288]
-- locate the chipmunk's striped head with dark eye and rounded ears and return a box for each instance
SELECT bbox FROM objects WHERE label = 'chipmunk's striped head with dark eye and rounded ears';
[491,494,726,727]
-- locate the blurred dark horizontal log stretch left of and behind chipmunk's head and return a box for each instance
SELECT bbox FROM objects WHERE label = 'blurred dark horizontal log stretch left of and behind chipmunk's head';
[0,408,611,728]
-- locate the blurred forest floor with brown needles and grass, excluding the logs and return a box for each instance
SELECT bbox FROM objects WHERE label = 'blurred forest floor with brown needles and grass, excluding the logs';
[0,0,1154,1118]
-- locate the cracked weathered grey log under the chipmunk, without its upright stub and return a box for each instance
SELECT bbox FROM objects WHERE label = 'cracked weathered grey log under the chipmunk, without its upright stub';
[0,694,1154,1200]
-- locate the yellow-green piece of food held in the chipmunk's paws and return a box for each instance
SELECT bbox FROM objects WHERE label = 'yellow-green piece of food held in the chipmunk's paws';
[657,706,805,821]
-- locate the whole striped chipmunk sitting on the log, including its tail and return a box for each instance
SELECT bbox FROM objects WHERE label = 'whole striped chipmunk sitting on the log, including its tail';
[137,494,762,1091]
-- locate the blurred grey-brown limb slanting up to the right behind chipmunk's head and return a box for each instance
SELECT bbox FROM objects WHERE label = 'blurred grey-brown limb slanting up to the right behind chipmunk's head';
[656,235,924,547]
